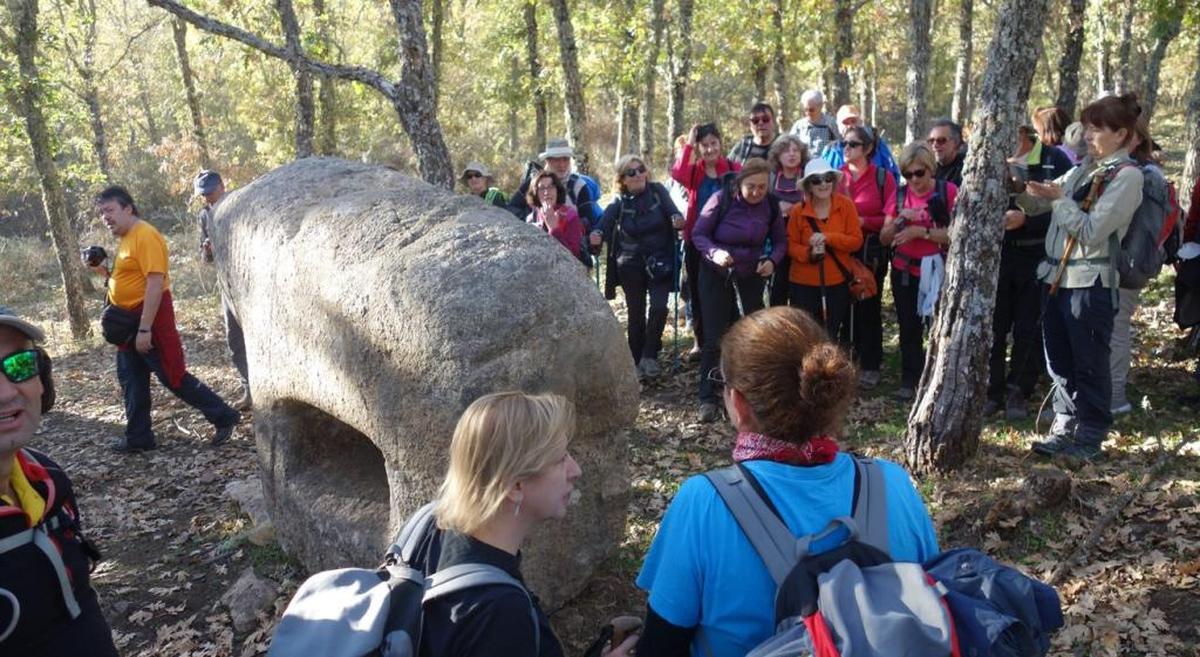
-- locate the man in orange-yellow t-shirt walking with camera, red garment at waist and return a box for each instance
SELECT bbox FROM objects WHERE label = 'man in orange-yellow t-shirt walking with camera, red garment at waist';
[94,186,241,453]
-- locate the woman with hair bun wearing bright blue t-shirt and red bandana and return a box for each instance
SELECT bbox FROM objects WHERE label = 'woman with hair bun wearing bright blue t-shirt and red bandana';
[637,307,938,657]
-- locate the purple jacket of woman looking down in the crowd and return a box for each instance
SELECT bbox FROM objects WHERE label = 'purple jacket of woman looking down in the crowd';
[691,189,787,276]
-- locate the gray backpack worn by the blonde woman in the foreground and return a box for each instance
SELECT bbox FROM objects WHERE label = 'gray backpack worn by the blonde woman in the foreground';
[266,504,541,657]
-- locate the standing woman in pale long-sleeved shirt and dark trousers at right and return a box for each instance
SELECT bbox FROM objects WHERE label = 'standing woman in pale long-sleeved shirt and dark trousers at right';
[1018,94,1144,465]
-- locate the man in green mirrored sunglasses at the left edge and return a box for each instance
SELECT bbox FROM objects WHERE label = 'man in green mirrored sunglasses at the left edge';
[0,307,116,657]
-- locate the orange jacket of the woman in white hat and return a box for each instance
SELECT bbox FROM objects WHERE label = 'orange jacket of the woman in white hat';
[787,192,863,287]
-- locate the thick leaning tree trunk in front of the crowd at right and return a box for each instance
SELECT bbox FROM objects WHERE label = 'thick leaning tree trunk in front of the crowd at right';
[905,0,1049,474]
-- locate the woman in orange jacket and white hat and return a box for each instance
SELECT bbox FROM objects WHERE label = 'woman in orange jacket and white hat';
[787,157,863,336]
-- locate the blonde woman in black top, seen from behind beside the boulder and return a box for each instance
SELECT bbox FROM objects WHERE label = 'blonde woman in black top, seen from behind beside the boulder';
[415,392,637,657]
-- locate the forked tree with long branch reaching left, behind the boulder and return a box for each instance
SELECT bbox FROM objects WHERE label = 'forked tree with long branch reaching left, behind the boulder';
[146,0,454,189]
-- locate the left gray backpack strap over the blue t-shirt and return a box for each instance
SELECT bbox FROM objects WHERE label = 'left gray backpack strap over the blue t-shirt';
[704,465,799,586]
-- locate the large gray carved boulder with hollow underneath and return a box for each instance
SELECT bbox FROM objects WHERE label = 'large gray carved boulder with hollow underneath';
[212,158,637,607]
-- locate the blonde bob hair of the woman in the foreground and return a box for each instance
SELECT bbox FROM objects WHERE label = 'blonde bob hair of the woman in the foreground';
[436,392,575,534]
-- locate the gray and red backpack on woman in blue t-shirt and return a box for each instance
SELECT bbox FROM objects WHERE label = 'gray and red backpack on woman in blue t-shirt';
[706,457,959,657]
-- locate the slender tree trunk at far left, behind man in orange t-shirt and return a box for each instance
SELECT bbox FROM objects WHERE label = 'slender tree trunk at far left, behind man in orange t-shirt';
[5,0,91,340]
